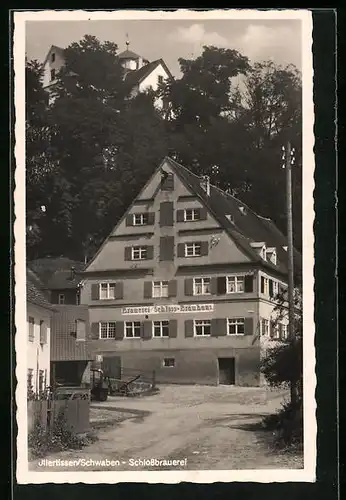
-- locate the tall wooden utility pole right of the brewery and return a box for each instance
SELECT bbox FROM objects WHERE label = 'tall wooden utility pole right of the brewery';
[282,141,297,404]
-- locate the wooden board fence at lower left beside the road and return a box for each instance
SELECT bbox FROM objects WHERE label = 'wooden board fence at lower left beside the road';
[28,394,90,433]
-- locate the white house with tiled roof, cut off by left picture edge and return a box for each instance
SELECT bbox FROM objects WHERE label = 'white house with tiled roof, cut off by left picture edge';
[26,269,53,394]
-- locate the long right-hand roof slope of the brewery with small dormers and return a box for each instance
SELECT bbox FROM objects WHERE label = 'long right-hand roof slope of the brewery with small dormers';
[166,157,301,274]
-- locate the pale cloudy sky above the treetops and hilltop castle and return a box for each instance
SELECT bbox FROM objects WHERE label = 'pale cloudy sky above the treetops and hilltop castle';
[26,19,302,77]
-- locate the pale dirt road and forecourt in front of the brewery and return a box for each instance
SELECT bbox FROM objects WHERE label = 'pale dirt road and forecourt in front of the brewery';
[30,386,303,472]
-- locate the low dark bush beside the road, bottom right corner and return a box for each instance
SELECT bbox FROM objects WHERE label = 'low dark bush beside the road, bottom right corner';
[263,400,303,449]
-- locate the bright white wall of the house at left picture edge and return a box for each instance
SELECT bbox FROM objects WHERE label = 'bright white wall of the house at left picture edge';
[27,302,51,392]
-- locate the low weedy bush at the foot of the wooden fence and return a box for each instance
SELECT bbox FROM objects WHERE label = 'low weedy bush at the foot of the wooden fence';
[28,410,96,458]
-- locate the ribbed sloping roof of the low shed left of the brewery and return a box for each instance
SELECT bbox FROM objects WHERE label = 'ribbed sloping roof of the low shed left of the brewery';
[50,305,92,361]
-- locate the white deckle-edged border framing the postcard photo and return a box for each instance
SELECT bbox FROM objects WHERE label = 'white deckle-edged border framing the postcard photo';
[14,9,317,484]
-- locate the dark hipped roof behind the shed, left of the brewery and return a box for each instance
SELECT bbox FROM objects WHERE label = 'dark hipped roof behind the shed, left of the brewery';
[28,257,85,290]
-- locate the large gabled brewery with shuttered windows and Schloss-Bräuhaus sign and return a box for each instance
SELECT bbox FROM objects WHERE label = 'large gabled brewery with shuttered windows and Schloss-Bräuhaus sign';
[81,158,299,386]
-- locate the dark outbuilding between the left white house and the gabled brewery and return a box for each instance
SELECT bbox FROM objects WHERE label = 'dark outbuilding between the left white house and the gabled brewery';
[29,257,91,386]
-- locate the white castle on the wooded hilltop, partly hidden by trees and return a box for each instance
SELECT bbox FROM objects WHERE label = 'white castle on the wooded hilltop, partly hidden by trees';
[43,42,173,107]
